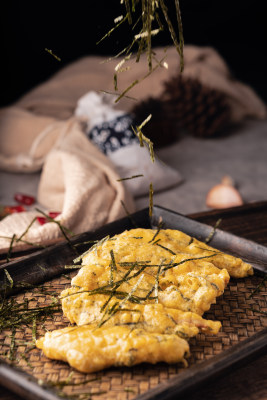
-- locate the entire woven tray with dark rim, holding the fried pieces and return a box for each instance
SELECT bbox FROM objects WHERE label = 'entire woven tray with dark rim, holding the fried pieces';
[0,207,267,400]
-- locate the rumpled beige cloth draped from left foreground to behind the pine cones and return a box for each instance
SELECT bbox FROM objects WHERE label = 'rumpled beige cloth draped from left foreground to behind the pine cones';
[0,46,266,247]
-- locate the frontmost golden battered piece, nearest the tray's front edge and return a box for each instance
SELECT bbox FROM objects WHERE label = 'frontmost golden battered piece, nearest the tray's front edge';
[36,326,189,373]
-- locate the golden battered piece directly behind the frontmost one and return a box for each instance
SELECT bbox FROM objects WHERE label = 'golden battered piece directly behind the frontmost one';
[61,288,221,338]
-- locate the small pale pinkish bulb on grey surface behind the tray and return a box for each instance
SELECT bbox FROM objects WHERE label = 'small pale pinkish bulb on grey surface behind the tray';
[206,176,243,208]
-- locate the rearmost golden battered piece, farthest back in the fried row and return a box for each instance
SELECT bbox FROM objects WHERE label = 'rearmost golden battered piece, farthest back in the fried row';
[79,228,253,278]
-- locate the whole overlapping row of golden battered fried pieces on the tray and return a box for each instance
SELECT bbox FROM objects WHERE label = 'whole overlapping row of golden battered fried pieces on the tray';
[36,228,253,372]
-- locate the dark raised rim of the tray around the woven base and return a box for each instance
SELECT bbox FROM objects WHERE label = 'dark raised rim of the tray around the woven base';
[0,206,267,400]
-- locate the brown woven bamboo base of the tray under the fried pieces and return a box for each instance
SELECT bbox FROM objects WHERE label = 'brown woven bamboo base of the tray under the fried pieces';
[0,273,267,400]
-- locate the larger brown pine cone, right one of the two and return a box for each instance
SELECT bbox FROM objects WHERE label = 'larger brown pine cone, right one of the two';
[162,75,230,137]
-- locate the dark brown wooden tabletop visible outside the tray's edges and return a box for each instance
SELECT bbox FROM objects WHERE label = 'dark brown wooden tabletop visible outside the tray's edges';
[0,201,267,400]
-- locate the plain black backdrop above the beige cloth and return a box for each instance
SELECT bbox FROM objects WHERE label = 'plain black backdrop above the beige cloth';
[0,0,267,106]
